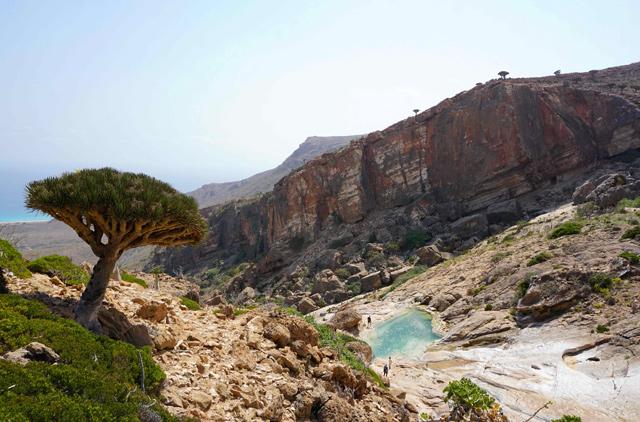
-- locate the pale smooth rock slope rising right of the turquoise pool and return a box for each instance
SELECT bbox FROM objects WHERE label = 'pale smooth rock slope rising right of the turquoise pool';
[314,199,640,422]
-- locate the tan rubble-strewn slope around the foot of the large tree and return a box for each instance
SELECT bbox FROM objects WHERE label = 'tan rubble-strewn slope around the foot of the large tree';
[7,273,416,422]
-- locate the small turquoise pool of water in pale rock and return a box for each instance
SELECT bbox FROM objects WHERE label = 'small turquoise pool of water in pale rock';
[366,309,440,359]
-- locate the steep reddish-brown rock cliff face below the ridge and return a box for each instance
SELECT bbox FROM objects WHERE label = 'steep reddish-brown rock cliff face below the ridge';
[159,64,640,272]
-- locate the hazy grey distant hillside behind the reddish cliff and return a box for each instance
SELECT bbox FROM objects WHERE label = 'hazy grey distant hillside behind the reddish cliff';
[188,135,362,208]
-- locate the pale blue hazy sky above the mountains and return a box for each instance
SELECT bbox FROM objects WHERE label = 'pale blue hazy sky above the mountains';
[0,0,640,221]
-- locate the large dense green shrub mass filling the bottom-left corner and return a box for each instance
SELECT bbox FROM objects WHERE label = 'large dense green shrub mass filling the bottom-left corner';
[0,294,176,421]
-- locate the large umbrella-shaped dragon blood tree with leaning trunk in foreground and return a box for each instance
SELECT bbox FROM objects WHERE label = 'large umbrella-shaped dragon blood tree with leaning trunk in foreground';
[25,168,207,332]
